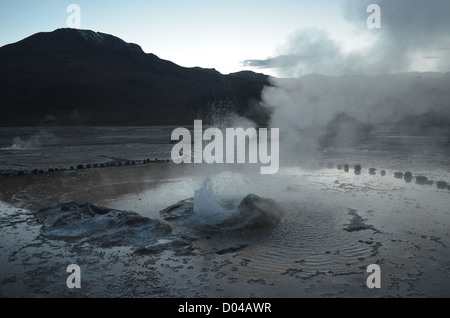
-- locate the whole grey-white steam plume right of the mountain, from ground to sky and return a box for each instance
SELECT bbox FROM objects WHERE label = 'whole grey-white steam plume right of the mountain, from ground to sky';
[244,0,450,163]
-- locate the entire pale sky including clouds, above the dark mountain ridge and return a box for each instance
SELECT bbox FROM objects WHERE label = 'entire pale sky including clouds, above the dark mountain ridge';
[0,0,450,76]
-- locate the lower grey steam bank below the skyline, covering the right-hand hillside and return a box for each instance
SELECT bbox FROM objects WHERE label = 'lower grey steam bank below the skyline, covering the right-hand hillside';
[262,72,450,162]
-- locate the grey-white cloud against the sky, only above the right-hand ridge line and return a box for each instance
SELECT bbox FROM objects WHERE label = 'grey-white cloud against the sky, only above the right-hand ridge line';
[242,0,450,77]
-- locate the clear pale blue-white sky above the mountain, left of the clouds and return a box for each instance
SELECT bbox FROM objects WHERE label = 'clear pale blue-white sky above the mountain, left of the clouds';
[0,0,370,74]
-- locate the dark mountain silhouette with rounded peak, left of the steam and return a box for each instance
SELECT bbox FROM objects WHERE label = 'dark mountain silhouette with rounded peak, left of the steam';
[0,29,270,126]
